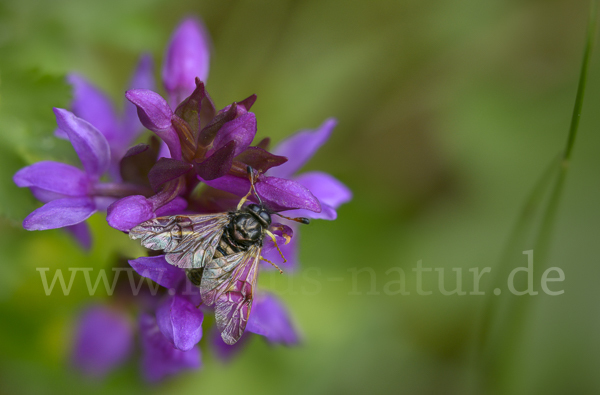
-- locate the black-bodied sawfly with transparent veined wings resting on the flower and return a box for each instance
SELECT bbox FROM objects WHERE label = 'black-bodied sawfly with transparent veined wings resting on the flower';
[129,166,309,345]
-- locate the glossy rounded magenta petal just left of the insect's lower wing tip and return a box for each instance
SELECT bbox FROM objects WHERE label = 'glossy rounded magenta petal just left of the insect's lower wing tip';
[156,295,204,351]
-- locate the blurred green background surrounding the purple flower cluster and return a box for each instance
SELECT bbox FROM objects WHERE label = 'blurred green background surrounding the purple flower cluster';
[0,0,600,394]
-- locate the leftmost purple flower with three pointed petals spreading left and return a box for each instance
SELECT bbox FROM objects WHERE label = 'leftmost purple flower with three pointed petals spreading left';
[13,108,151,240]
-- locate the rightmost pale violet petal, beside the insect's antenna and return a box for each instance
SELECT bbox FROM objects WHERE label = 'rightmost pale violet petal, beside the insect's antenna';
[286,171,352,220]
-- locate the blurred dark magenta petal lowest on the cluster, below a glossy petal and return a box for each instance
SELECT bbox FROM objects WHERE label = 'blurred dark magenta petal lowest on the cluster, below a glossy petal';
[140,314,201,382]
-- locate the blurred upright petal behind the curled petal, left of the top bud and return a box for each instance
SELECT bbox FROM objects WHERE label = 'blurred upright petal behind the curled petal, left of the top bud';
[123,54,156,140]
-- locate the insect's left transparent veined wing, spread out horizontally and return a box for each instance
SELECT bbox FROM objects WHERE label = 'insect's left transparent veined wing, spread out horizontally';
[129,213,229,269]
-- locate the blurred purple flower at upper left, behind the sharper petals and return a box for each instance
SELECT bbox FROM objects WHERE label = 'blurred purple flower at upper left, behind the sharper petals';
[55,55,155,181]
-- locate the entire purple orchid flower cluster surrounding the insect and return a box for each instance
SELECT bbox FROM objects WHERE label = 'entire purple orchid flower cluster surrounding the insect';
[14,19,351,381]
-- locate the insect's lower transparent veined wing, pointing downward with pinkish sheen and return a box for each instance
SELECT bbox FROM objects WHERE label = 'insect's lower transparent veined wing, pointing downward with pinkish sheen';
[200,246,261,344]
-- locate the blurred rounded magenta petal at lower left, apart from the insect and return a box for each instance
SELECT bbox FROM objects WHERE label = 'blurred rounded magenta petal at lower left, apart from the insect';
[72,306,133,378]
